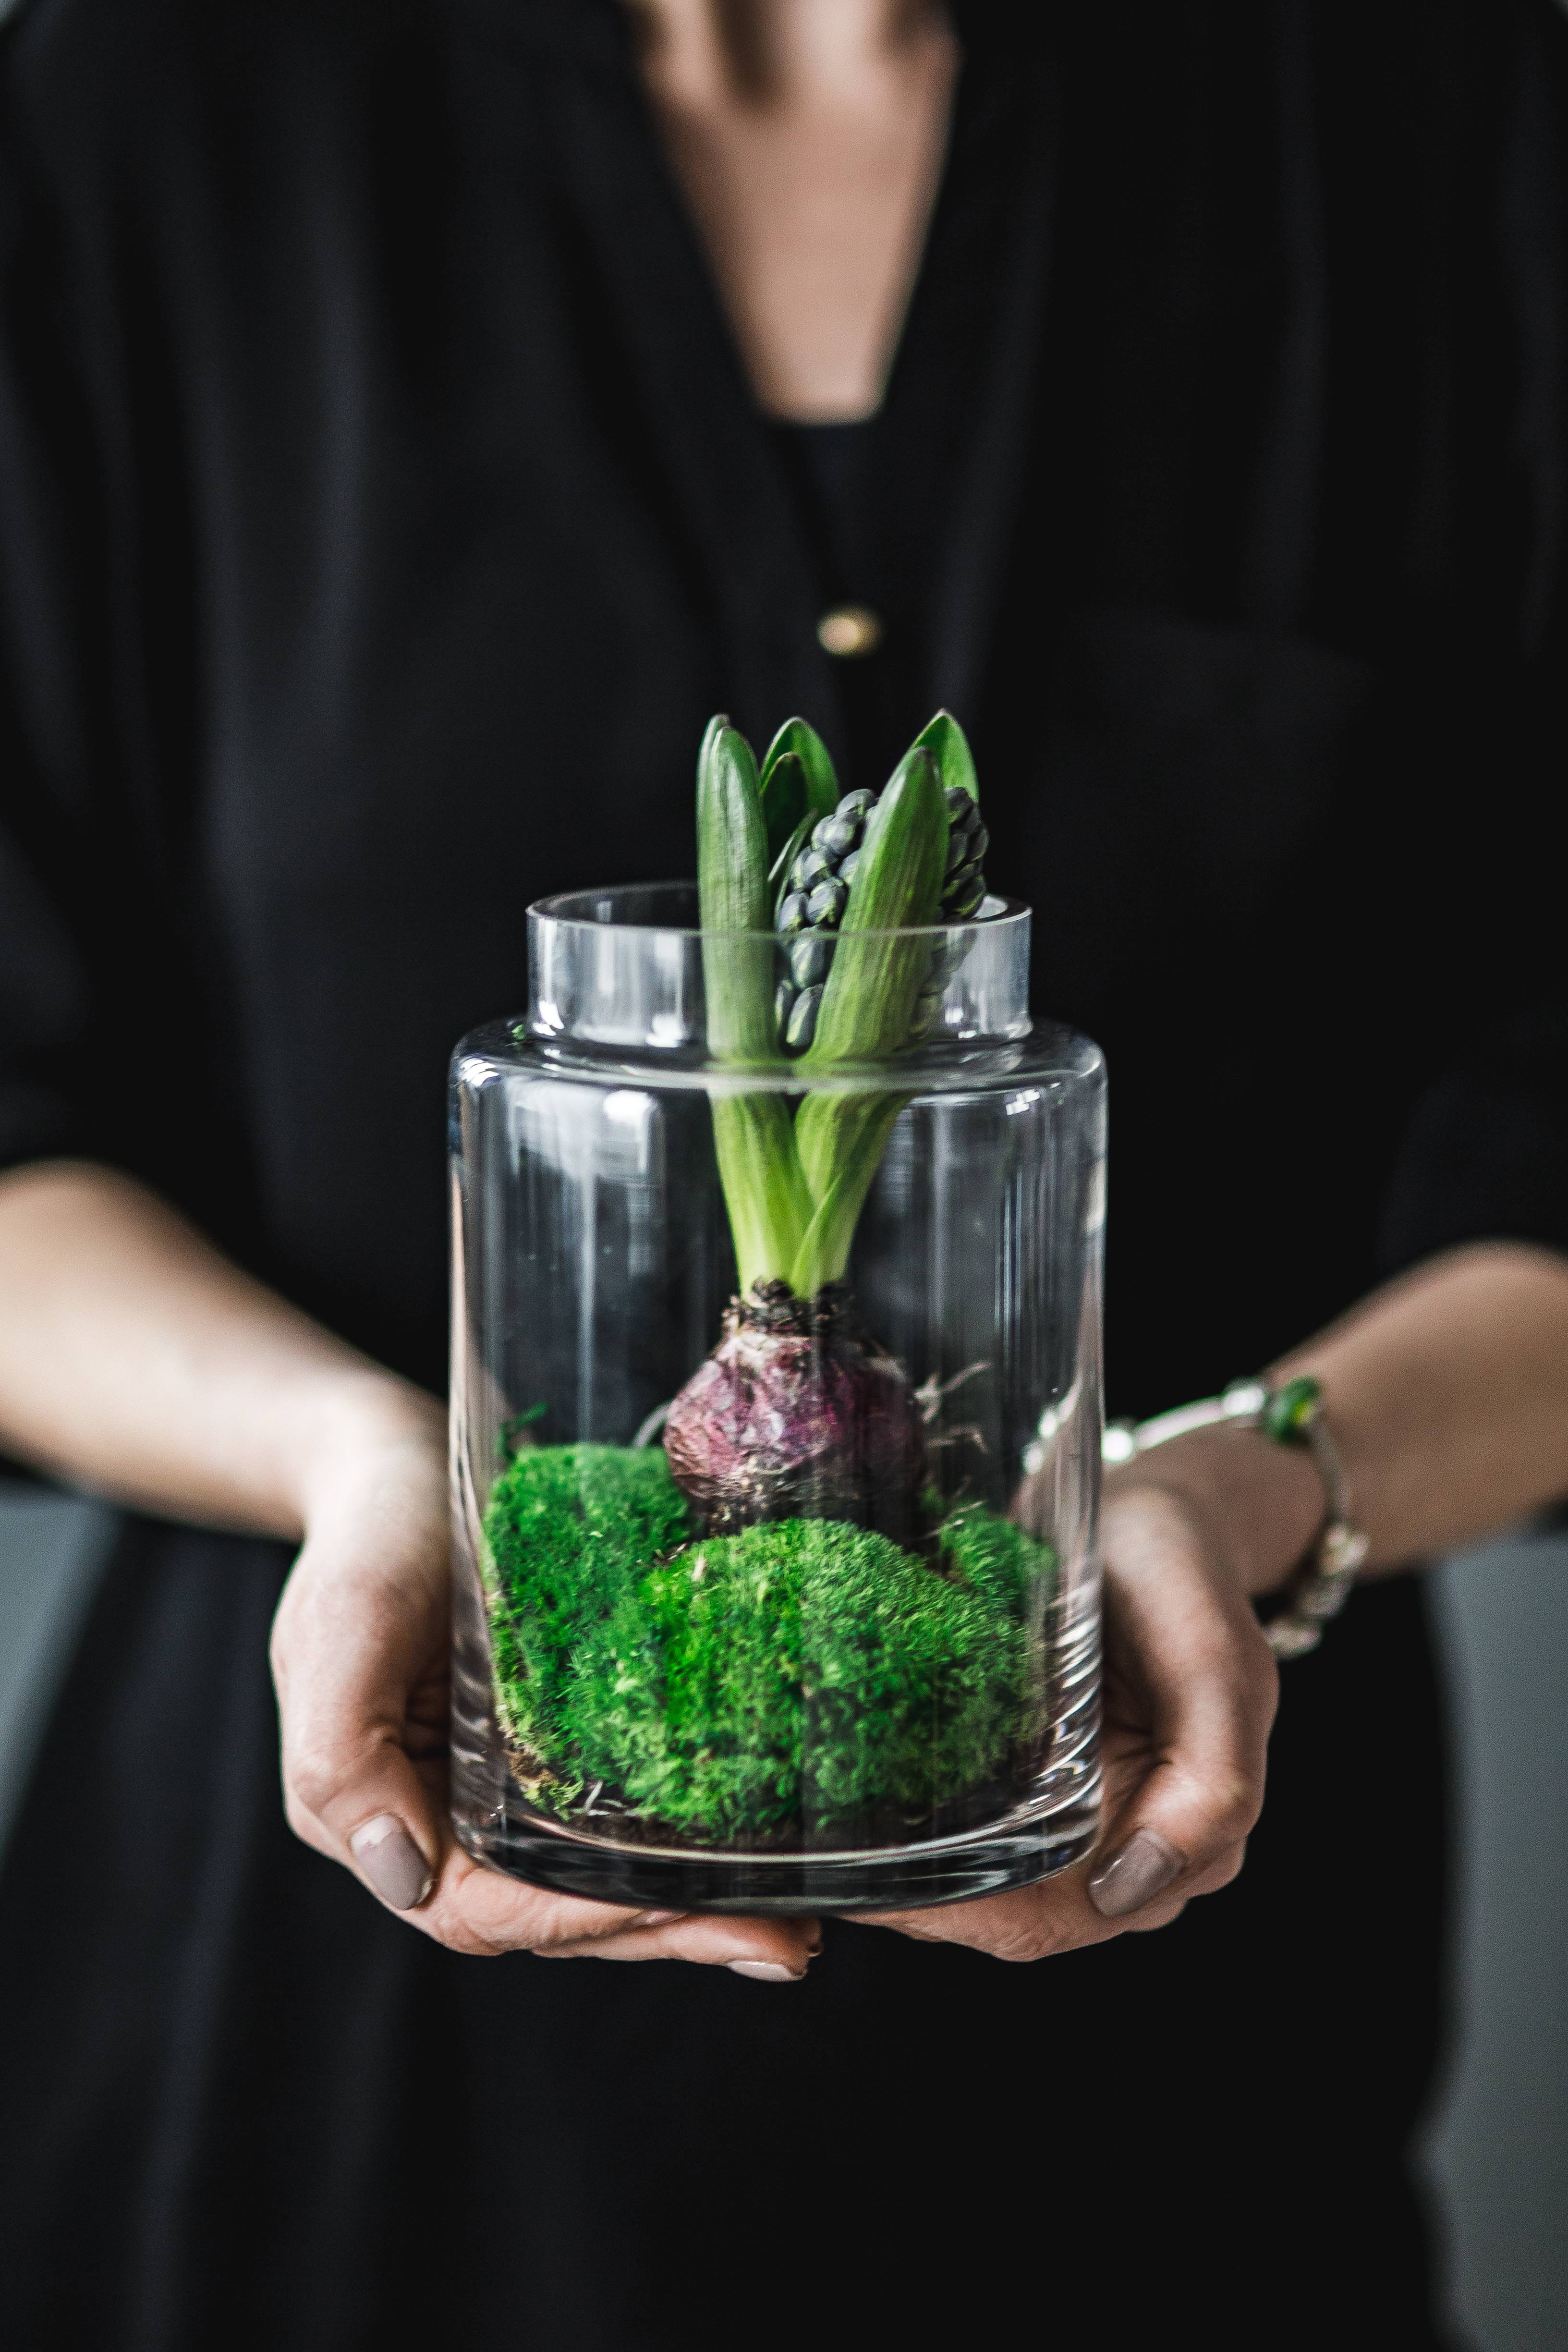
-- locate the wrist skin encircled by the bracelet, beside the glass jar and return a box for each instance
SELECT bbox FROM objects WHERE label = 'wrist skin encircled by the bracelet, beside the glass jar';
[1105,1427,1326,1599]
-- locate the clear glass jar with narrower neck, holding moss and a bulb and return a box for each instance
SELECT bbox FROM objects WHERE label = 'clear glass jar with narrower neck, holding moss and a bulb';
[451,884,1105,1912]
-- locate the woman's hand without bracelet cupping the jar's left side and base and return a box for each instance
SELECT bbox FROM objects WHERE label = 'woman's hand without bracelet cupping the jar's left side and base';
[273,1388,818,1983]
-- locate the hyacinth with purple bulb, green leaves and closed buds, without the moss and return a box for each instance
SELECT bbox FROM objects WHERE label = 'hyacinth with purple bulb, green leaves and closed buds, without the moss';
[665,710,985,1543]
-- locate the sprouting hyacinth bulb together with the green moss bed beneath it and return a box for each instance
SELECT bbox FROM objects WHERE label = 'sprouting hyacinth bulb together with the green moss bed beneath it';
[484,713,1053,1846]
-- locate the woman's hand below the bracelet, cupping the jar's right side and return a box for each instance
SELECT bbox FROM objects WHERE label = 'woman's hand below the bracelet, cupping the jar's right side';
[872,1449,1288,1959]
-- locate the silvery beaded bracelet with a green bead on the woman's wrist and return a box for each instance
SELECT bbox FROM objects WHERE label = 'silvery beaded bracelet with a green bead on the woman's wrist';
[1103,1374,1368,1658]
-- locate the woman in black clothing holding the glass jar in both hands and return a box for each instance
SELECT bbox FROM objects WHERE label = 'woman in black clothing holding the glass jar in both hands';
[0,0,1568,2352]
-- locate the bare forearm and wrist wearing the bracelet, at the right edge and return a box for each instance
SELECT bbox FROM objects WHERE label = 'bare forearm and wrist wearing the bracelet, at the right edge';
[1121,1242,1568,1592]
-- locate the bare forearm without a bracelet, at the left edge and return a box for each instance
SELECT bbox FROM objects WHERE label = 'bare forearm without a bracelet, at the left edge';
[0,1162,439,1536]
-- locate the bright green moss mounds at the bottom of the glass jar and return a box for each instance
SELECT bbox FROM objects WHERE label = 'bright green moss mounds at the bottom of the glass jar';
[484,1447,1053,1844]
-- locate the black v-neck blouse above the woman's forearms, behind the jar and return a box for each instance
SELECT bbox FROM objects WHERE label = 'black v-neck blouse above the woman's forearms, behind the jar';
[0,0,1568,1409]
